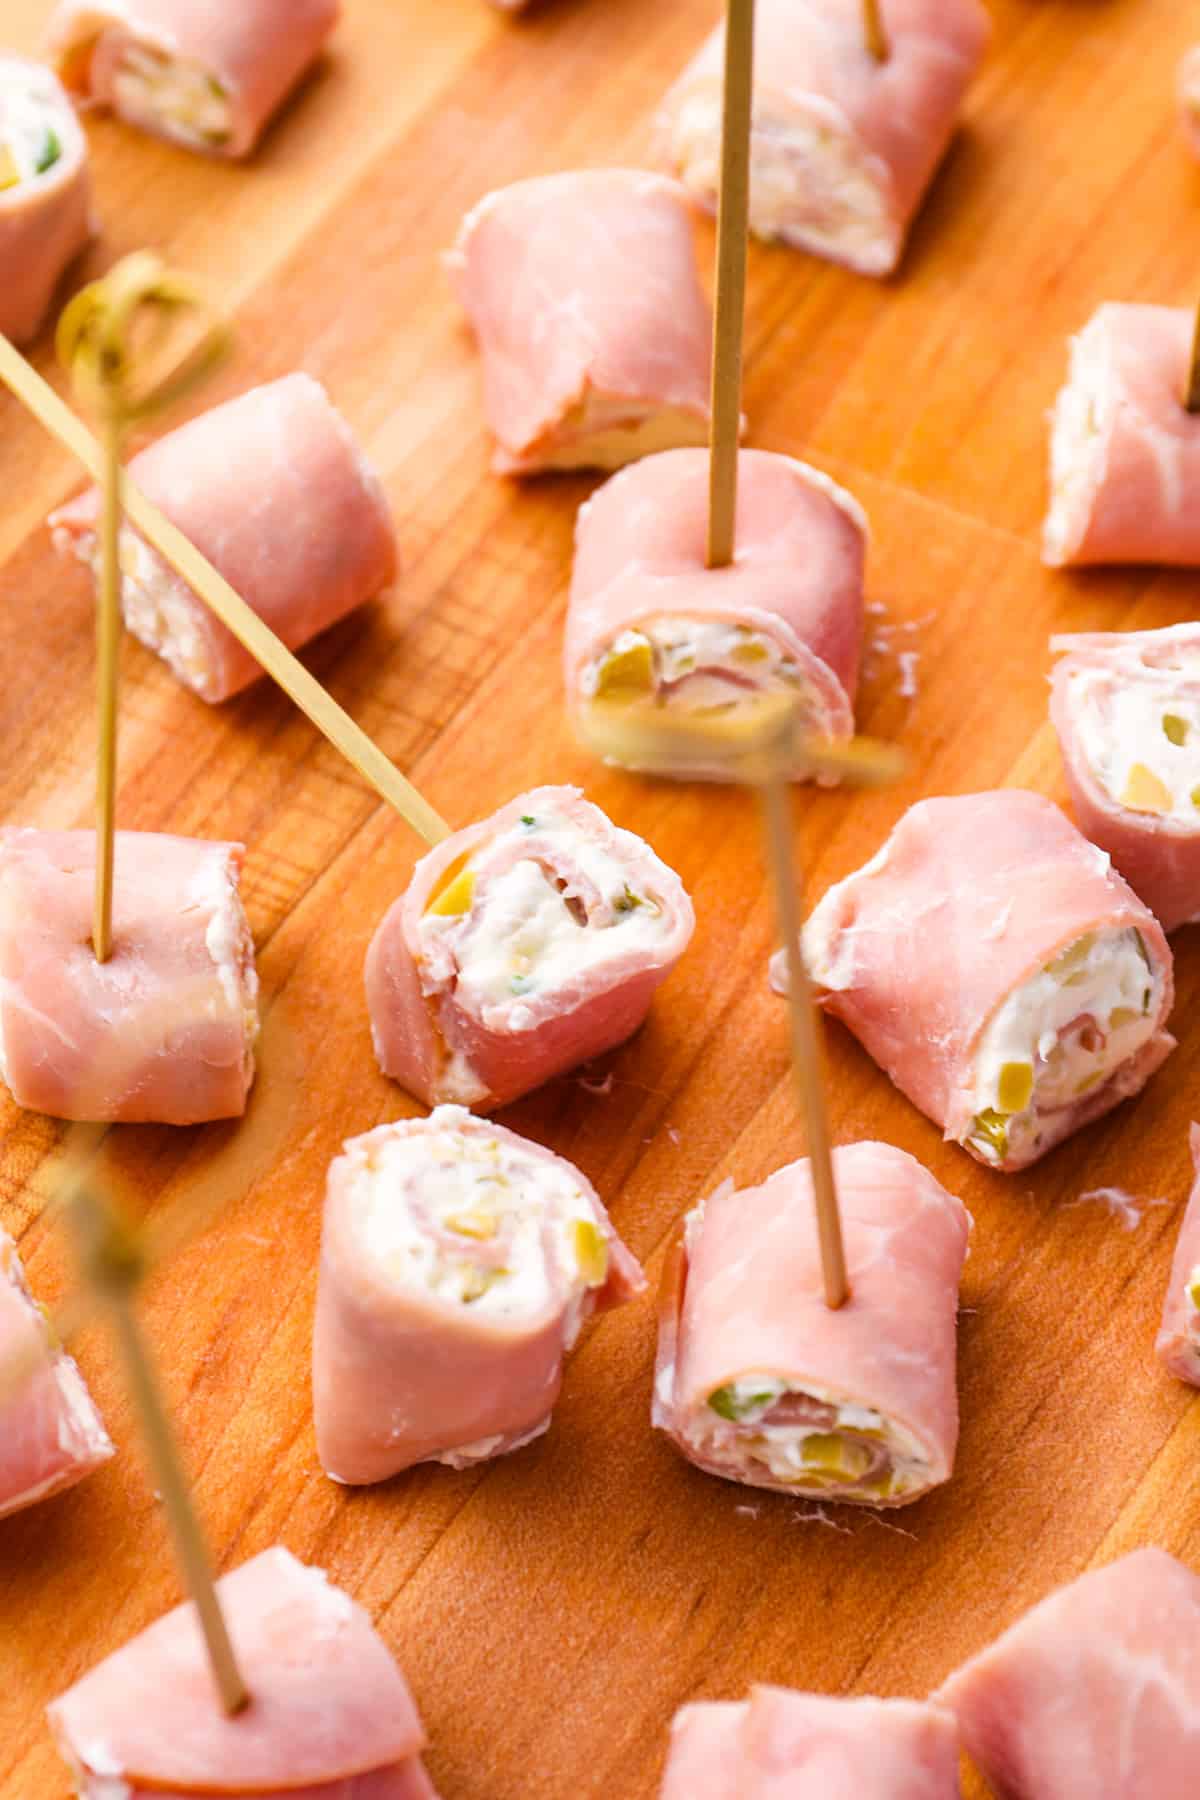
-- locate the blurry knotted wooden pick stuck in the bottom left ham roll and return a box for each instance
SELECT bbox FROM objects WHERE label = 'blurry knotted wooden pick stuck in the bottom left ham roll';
[63,1172,250,1715]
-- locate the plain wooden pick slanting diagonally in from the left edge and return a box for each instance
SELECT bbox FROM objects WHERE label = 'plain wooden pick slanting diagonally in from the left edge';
[0,320,450,844]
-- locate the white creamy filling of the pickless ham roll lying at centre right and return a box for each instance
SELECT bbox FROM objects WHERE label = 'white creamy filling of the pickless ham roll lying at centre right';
[970,927,1162,1163]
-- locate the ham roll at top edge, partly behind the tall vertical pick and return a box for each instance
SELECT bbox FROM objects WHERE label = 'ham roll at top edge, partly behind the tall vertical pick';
[660,0,991,275]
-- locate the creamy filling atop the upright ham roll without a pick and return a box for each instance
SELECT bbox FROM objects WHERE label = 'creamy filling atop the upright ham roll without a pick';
[347,1107,608,1332]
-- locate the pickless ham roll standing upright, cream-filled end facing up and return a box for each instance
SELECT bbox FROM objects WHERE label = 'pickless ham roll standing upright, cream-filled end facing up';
[313,1107,646,1483]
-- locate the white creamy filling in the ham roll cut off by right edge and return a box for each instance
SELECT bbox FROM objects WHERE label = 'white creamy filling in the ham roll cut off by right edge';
[1070,655,1200,830]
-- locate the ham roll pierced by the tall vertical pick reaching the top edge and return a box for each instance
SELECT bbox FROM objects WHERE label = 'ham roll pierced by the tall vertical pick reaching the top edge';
[565,450,867,779]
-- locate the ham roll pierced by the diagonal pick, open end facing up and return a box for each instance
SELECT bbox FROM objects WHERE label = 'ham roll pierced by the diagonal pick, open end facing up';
[365,787,694,1109]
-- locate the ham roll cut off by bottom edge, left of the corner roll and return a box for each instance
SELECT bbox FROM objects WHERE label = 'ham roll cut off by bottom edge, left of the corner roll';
[660,1687,959,1800]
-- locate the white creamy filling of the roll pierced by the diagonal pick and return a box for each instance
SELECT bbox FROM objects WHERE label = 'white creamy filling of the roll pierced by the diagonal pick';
[419,806,664,1031]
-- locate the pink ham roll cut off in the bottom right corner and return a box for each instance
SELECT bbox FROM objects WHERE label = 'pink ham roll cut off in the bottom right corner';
[934,1550,1200,1800]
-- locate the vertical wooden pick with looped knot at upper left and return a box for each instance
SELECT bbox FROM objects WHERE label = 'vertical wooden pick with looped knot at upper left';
[58,250,230,963]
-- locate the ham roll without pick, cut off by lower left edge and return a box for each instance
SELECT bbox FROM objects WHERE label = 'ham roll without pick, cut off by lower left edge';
[0,1229,113,1519]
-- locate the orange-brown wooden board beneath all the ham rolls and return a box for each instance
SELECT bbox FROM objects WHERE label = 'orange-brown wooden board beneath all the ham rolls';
[0,0,1200,1800]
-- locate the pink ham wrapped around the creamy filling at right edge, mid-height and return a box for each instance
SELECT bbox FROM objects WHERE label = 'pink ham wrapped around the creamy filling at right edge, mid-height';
[1051,625,1200,931]
